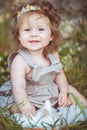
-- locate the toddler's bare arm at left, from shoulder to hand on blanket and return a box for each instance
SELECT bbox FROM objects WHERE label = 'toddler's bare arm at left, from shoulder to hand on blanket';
[11,55,35,116]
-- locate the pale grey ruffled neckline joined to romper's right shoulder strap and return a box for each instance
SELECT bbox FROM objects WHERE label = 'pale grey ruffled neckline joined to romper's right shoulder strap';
[33,54,63,81]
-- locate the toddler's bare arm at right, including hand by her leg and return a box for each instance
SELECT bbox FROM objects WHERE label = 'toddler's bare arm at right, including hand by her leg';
[54,53,70,106]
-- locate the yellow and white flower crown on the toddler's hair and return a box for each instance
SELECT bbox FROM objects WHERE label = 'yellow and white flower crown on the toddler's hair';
[17,4,40,20]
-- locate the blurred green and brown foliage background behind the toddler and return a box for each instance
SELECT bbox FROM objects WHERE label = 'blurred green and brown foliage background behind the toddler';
[0,0,87,130]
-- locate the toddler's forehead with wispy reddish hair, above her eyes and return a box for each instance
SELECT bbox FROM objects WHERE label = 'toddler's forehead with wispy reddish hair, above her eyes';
[19,13,50,26]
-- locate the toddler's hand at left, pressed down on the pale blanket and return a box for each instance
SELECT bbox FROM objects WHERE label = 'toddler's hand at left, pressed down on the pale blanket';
[20,103,36,117]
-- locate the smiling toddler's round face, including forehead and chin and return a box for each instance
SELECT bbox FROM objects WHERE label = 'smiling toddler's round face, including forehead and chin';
[19,14,53,51]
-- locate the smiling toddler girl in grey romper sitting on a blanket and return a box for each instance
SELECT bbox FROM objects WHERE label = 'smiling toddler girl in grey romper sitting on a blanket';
[0,0,87,117]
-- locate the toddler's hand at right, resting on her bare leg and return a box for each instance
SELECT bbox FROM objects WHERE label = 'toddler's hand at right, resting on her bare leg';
[58,92,71,107]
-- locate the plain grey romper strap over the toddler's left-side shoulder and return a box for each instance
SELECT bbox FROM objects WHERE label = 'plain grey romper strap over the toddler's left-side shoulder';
[18,49,38,68]
